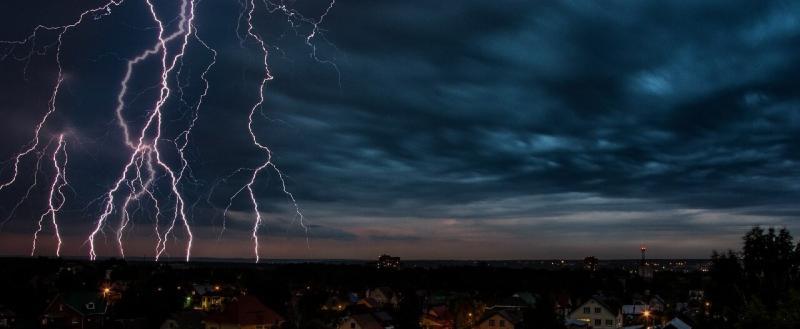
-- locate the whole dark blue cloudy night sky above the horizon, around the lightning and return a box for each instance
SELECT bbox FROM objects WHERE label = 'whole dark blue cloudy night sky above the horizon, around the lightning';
[0,0,800,259]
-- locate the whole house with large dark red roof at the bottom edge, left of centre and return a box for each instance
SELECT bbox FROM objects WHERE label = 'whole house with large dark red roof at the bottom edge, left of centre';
[203,296,285,329]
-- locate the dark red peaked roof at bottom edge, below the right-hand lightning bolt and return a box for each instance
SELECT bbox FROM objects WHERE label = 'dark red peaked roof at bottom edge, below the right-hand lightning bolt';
[206,296,284,325]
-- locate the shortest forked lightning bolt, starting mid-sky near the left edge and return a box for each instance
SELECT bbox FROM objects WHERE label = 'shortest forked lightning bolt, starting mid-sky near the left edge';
[31,134,69,256]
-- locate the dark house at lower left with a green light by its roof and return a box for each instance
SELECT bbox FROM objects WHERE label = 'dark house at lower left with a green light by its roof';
[42,292,108,329]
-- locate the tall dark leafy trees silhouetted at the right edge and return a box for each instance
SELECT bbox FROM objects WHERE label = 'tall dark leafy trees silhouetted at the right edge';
[698,226,800,329]
